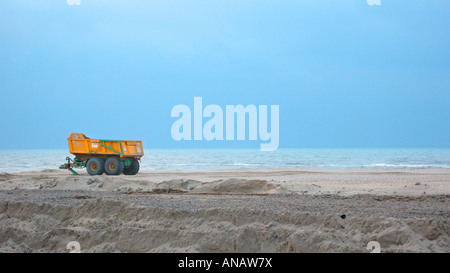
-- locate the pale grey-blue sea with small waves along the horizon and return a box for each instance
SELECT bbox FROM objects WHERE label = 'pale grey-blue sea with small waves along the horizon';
[0,148,450,173]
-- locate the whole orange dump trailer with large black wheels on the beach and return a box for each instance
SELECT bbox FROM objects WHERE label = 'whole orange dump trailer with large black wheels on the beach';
[60,133,144,175]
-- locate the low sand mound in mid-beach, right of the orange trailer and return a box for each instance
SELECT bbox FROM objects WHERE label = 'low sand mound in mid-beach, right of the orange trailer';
[152,178,284,194]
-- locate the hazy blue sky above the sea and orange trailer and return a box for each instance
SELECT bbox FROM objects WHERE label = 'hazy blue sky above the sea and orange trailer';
[0,0,450,149]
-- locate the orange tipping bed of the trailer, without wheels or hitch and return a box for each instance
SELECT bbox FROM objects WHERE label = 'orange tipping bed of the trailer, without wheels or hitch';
[67,133,144,159]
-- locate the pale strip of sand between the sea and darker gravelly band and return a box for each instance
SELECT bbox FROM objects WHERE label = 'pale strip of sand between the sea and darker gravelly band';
[0,169,450,196]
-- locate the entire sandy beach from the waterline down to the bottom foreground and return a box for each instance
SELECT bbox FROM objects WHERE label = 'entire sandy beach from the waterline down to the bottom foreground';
[0,169,450,252]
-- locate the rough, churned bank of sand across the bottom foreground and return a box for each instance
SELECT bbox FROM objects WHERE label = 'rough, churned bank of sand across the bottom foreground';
[0,199,450,252]
